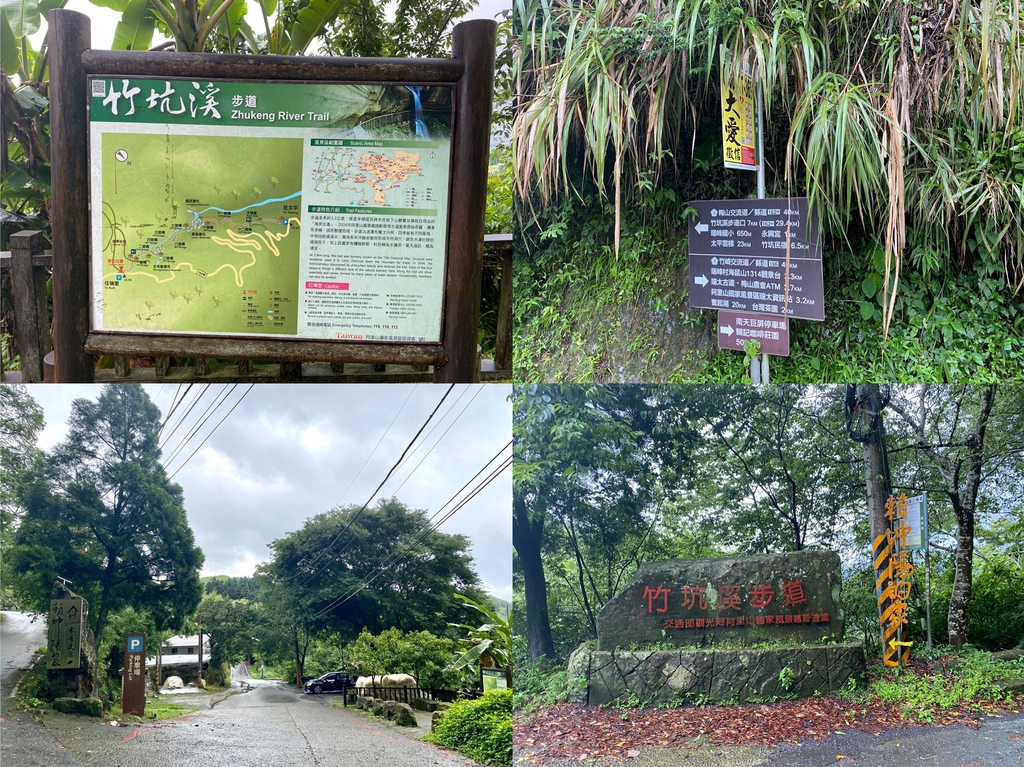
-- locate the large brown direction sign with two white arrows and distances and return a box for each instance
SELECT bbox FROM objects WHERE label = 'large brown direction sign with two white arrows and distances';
[689,198,825,321]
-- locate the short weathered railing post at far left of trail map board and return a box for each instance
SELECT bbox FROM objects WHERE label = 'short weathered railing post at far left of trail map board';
[10,231,50,383]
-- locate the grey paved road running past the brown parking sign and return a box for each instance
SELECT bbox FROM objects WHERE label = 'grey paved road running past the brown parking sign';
[0,613,476,767]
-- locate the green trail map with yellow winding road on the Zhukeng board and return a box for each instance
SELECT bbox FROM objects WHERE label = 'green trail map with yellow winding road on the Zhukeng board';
[101,133,302,335]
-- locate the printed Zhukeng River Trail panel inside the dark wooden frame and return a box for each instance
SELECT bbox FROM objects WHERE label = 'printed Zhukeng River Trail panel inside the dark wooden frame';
[89,77,453,343]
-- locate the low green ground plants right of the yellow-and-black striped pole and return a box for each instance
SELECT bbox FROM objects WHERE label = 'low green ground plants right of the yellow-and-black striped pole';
[869,649,1021,723]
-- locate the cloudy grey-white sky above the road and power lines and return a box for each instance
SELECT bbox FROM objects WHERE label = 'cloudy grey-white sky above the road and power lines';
[17,384,512,600]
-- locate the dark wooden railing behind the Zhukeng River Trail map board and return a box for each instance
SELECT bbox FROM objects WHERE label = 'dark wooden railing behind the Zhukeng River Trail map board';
[0,231,512,383]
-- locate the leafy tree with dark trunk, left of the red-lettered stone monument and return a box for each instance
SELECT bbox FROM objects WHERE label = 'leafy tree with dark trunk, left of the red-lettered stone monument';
[512,385,691,661]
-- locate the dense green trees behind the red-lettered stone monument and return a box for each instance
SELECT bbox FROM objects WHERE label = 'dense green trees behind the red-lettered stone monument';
[513,385,1024,659]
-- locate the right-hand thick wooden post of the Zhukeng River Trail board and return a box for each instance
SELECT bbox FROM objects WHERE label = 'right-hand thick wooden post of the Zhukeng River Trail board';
[434,19,498,383]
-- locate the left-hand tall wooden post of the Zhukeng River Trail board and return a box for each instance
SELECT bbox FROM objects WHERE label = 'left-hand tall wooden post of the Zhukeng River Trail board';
[46,8,95,383]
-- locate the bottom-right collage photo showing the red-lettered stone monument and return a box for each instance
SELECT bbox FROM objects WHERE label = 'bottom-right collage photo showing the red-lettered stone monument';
[512,384,1024,767]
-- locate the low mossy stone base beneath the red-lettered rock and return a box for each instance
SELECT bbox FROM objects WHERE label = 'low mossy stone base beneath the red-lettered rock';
[568,642,865,706]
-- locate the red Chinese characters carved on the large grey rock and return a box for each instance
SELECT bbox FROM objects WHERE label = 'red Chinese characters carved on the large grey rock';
[640,578,829,630]
